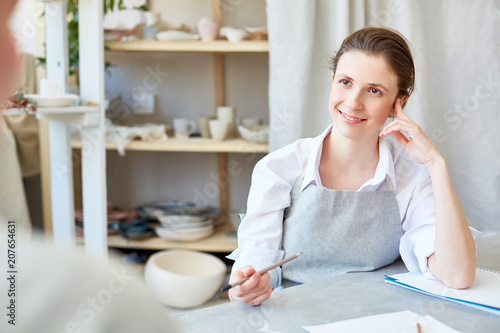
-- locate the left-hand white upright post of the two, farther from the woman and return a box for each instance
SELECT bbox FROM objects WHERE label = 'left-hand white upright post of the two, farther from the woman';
[45,1,75,248]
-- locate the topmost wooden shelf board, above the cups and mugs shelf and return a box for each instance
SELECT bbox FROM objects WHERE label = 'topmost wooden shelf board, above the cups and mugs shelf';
[106,40,269,53]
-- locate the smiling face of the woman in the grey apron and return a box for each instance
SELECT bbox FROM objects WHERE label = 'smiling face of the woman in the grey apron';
[329,51,398,139]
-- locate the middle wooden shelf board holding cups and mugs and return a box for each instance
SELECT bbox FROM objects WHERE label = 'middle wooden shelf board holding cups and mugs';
[71,138,269,153]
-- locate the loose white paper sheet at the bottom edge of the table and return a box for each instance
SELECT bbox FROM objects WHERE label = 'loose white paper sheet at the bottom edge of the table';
[304,311,459,333]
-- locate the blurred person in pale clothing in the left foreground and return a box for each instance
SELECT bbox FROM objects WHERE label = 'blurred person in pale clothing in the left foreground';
[0,0,177,333]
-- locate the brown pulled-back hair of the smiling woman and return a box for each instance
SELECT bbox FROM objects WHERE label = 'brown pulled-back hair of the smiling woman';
[331,28,415,97]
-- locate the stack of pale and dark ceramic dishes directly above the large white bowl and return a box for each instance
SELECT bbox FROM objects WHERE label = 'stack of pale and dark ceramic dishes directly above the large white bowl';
[146,201,217,241]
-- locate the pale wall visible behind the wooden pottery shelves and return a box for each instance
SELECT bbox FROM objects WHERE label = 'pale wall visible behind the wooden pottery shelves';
[105,0,268,209]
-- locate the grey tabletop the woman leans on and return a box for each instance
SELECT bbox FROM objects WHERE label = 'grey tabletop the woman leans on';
[177,234,500,333]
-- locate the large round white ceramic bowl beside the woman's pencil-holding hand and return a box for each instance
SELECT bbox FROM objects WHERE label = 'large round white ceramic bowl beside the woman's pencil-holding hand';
[144,250,226,309]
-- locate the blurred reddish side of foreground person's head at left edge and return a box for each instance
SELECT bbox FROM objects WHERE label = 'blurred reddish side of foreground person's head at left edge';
[0,0,18,105]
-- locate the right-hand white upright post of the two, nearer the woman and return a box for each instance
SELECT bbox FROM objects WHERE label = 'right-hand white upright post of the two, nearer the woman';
[79,0,108,259]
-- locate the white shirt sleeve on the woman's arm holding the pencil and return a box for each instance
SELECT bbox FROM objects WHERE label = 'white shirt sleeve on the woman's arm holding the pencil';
[227,139,309,288]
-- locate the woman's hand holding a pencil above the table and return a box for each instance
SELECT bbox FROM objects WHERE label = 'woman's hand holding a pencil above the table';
[229,266,273,305]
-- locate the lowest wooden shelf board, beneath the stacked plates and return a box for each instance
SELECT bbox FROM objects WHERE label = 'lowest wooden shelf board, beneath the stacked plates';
[76,223,238,253]
